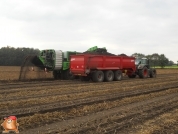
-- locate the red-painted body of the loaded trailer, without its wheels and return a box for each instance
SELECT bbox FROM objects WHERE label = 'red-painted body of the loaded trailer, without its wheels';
[70,54,136,76]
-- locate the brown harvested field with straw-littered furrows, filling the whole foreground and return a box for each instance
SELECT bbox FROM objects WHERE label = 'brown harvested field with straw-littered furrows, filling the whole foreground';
[0,69,178,134]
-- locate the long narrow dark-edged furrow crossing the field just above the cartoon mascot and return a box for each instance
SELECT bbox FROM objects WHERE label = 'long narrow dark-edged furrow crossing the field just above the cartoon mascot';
[0,85,178,117]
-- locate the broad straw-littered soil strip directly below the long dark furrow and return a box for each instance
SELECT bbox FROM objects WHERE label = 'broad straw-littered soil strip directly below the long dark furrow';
[19,89,178,133]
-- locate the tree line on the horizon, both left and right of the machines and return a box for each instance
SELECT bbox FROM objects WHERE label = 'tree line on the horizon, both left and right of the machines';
[0,46,174,68]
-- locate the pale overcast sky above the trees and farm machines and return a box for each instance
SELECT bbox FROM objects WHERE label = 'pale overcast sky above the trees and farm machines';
[0,0,178,63]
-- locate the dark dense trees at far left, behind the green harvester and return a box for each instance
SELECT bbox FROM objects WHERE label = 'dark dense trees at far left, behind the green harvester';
[0,47,40,66]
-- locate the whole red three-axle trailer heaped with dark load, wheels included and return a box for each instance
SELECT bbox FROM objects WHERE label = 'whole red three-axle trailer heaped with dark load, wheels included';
[70,54,136,82]
